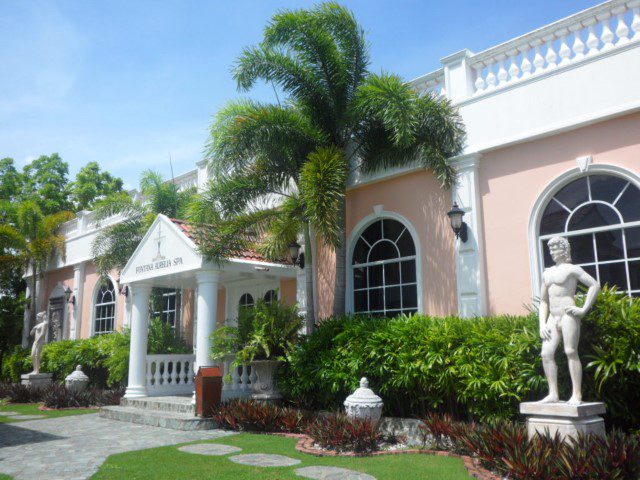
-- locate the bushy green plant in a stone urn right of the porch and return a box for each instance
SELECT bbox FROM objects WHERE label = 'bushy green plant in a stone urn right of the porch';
[212,300,304,401]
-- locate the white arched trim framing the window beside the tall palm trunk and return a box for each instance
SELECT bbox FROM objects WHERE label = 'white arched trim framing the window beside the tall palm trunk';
[345,210,424,313]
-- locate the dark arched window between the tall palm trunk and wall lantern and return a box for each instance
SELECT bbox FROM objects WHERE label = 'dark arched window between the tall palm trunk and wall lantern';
[351,219,418,316]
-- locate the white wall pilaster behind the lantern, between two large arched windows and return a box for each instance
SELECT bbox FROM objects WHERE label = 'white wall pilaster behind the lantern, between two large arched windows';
[453,154,487,317]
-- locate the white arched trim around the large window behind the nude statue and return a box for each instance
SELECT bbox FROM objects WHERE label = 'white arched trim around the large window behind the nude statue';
[529,164,640,298]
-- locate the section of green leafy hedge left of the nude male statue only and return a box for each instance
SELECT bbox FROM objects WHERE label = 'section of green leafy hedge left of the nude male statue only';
[281,315,542,418]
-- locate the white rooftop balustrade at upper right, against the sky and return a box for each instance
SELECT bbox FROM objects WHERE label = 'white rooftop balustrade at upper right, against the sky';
[469,0,640,95]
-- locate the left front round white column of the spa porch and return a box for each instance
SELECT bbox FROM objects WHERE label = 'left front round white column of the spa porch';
[124,285,151,398]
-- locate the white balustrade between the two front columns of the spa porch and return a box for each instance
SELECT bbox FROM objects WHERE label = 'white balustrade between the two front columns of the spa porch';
[147,354,196,396]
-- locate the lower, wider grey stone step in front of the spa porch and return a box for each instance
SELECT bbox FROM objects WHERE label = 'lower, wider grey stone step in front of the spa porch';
[100,406,217,431]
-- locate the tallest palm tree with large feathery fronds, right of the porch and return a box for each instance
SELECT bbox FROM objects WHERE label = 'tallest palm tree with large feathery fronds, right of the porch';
[198,2,465,315]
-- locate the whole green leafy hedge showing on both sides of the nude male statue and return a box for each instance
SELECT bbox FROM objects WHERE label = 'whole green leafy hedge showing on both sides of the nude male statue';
[280,289,640,429]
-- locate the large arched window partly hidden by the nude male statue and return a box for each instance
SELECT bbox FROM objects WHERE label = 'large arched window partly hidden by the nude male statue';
[538,173,640,296]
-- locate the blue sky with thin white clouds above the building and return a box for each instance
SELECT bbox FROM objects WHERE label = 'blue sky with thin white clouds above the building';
[0,0,598,188]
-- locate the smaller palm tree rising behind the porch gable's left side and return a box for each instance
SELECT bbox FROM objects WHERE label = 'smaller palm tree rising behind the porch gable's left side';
[91,170,194,275]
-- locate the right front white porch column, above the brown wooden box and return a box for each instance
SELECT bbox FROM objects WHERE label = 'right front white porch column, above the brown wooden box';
[194,271,220,374]
